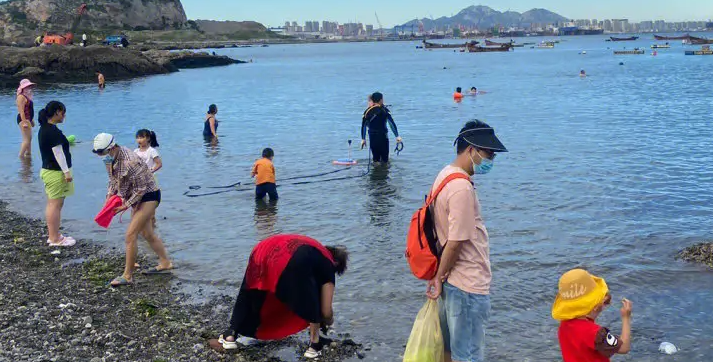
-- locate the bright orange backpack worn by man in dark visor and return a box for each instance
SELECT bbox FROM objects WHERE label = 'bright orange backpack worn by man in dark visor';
[406,172,470,280]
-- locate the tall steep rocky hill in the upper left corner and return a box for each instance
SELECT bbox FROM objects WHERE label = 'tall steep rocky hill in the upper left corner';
[0,0,187,42]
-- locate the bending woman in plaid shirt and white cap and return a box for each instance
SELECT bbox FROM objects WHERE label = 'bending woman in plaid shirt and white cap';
[92,133,173,287]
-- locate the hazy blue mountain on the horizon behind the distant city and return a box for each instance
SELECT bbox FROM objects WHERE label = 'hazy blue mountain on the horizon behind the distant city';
[402,5,569,30]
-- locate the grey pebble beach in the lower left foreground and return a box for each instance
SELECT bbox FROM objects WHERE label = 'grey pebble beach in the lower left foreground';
[0,202,364,362]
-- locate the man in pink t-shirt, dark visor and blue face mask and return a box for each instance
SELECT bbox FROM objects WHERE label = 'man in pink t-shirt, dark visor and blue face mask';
[427,121,507,362]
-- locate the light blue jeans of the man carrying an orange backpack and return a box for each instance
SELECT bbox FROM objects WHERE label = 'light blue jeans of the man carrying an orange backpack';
[439,283,490,362]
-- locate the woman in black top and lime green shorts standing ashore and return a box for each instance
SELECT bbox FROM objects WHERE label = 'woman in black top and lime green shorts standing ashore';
[37,101,77,246]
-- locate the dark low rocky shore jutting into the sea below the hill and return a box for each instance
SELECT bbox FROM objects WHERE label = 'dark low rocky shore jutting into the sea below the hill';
[0,45,245,87]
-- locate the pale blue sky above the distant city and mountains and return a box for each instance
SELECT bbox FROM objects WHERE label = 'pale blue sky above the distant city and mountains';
[182,0,713,27]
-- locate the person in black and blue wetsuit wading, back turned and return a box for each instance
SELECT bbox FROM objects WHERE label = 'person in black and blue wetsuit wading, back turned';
[361,92,402,163]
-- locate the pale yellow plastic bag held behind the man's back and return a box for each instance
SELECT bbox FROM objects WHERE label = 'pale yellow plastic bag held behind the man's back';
[403,299,444,362]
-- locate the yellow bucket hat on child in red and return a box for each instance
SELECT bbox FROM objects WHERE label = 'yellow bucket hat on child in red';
[552,269,609,321]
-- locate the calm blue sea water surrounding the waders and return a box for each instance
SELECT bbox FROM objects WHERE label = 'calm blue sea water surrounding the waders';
[0,36,713,361]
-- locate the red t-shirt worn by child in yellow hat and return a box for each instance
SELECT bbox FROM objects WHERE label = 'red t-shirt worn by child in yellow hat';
[558,319,621,362]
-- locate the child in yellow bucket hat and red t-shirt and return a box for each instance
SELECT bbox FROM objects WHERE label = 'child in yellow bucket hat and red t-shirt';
[552,269,632,362]
